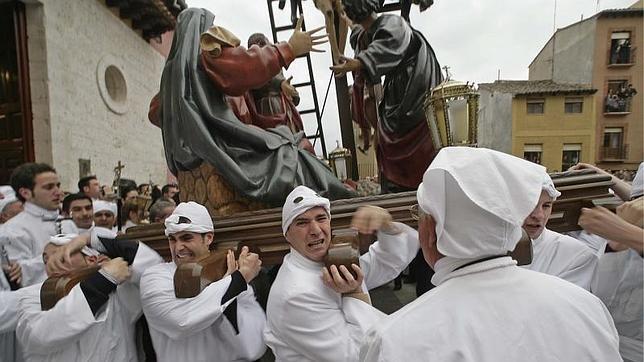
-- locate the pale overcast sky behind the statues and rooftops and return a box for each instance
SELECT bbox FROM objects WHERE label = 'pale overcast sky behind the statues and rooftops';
[187,0,635,151]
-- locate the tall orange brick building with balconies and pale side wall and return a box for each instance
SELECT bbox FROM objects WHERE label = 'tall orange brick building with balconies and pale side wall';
[529,0,644,170]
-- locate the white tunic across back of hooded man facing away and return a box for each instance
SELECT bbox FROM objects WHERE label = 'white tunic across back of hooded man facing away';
[360,257,620,362]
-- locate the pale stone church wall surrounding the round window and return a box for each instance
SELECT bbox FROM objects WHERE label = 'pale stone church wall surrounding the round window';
[27,0,166,191]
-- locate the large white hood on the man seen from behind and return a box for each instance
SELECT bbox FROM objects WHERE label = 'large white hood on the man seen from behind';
[417,147,545,259]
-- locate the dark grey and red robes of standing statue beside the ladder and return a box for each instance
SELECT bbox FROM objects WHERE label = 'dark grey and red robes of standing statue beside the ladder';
[351,15,442,189]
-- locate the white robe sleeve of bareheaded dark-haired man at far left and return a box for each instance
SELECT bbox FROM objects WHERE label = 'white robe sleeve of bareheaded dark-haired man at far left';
[2,227,47,286]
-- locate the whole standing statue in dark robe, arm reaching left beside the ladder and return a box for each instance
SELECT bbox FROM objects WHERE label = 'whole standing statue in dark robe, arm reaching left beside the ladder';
[332,0,443,193]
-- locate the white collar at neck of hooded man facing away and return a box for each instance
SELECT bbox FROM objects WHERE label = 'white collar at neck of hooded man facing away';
[432,256,517,286]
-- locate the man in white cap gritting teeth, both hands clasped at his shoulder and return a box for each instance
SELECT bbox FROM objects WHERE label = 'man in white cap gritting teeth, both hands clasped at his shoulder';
[141,201,266,362]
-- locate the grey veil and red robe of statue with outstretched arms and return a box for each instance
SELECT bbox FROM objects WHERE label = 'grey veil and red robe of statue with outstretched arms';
[150,9,351,205]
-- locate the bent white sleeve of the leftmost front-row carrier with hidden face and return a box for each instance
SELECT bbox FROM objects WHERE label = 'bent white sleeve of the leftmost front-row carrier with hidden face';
[16,284,101,354]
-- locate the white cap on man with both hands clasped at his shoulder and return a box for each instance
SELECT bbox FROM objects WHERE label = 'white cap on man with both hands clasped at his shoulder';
[165,201,215,236]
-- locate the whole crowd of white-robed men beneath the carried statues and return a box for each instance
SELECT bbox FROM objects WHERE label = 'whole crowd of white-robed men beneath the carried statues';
[0,147,644,361]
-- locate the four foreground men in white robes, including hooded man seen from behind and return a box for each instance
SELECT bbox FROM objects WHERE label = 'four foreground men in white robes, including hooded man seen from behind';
[0,147,640,361]
